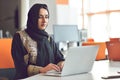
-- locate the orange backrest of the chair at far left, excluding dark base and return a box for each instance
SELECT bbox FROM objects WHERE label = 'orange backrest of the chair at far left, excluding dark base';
[0,38,14,68]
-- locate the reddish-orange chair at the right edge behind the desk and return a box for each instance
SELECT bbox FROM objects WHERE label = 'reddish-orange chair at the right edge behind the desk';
[106,41,120,61]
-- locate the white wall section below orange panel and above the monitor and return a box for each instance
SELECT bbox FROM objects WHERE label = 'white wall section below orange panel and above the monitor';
[57,5,78,25]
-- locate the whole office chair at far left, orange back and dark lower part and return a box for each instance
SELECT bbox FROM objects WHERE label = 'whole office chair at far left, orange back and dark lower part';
[0,38,15,80]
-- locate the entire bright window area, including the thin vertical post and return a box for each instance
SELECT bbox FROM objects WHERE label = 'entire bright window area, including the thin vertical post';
[69,0,120,41]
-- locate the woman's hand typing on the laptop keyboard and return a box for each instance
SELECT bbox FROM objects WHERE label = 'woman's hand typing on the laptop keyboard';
[40,63,61,73]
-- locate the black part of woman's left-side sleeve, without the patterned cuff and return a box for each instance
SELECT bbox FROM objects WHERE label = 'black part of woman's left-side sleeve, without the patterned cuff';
[11,33,28,79]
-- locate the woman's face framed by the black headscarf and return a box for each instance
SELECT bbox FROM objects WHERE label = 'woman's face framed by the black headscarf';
[38,8,49,30]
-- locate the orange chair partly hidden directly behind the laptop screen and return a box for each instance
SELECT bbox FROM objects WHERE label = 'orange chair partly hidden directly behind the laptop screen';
[82,42,106,60]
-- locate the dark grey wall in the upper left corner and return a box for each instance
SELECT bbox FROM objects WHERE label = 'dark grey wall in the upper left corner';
[0,0,18,36]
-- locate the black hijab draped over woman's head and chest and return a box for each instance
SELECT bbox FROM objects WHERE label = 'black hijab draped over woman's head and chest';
[25,4,55,67]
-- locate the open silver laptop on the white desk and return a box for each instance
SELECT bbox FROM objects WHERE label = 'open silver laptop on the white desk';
[45,46,99,76]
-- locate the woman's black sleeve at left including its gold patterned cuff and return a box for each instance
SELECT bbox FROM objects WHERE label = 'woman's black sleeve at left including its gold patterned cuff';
[12,33,42,79]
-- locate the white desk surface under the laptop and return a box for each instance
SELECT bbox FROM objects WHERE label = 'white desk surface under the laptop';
[22,60,120,80]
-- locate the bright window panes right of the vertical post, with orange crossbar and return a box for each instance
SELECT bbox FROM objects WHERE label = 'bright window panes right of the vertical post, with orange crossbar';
[85,0,120,41]
